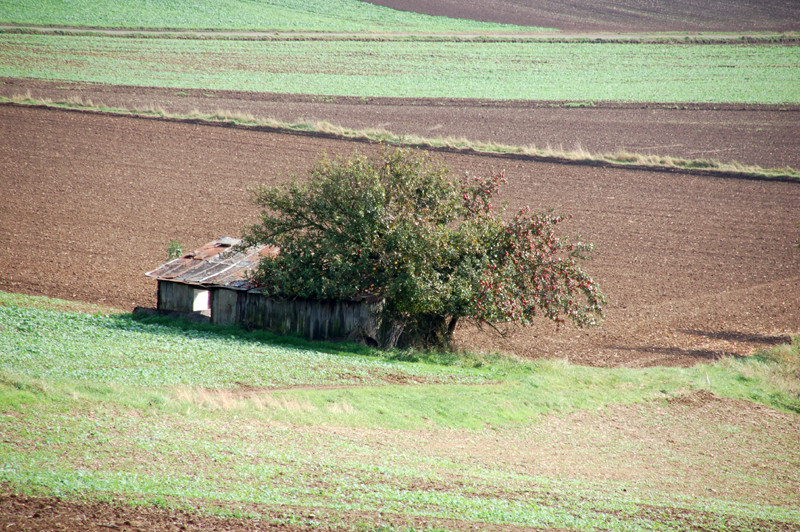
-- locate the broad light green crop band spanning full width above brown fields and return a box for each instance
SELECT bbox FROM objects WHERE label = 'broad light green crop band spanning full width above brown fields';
[0,34,800,104]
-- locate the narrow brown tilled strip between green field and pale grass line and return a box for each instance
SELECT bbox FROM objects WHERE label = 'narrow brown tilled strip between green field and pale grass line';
[0,78,800,168]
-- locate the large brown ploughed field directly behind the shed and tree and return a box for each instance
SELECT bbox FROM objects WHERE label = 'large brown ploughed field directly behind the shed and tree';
[0,105,800,366]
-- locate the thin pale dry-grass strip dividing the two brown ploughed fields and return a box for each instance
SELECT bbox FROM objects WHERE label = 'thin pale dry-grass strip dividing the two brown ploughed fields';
[6,94,800,181]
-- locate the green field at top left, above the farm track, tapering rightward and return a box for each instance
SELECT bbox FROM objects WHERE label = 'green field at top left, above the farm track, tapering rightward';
[0,0,546,34]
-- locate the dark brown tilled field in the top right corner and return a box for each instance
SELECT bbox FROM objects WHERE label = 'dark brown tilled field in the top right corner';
[366,0,800,32]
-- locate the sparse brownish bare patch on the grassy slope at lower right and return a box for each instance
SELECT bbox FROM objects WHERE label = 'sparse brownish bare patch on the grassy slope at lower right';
[302,391,800,508]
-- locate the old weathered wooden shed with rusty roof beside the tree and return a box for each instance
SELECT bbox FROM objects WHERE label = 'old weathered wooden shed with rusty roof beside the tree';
[146,237,383,344]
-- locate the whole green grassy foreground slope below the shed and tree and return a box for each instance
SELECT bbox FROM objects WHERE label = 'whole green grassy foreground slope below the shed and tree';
[0,293,800,530]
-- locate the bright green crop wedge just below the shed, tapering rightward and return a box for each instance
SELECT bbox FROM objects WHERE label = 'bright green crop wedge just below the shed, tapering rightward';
[0,295,497,388]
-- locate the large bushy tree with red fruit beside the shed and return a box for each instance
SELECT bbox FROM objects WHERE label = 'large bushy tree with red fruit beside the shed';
[245,148,604,347]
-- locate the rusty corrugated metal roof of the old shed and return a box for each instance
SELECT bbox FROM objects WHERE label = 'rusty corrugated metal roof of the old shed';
[145,237,278,290]
